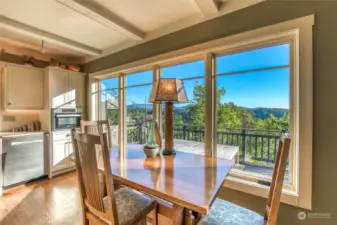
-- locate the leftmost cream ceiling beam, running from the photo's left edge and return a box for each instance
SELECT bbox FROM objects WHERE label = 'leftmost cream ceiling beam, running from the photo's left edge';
[0,15,102,56]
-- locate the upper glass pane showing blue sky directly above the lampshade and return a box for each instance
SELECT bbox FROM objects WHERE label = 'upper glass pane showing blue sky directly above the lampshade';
[161,60,205,79]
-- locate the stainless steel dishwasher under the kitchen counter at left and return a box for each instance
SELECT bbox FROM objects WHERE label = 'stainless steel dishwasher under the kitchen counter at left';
[2,133,47,188]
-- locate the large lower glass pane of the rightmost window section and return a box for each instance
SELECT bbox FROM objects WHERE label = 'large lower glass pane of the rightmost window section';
[217,69,290,182]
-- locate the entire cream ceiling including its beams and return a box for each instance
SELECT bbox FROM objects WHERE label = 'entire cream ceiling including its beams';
[0,0,264,62]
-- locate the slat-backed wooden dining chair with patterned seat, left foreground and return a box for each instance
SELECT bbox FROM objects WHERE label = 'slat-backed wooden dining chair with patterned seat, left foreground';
[72,129,158,225]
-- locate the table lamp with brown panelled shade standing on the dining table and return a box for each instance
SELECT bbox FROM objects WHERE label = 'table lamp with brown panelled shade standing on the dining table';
[149,78,187,155]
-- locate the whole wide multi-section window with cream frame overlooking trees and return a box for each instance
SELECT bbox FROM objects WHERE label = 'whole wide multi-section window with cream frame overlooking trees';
[91,16,314,209]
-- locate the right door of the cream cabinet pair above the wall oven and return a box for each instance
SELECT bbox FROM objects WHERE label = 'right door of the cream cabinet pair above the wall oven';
[68,72,86,108]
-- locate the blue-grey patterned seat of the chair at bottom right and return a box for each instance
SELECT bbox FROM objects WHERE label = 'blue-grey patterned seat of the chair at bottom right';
[198,199,265,225]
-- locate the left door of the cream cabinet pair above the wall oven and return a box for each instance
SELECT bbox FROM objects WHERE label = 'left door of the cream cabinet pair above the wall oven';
[50,69,69,108]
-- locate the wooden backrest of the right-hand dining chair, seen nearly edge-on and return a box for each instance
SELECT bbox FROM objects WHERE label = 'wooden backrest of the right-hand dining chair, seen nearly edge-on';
[265,136,291,225]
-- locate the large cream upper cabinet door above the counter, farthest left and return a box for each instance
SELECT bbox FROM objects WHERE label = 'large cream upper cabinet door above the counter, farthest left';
[4,65,43,110]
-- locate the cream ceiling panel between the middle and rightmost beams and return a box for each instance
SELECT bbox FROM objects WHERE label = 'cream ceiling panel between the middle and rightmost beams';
[94,0,200,32]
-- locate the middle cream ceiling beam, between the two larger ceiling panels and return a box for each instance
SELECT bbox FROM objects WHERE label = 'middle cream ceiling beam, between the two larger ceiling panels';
[56,0,145,41]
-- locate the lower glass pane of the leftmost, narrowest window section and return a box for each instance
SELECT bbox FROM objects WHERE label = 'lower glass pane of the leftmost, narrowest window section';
[99,89,119,147]
